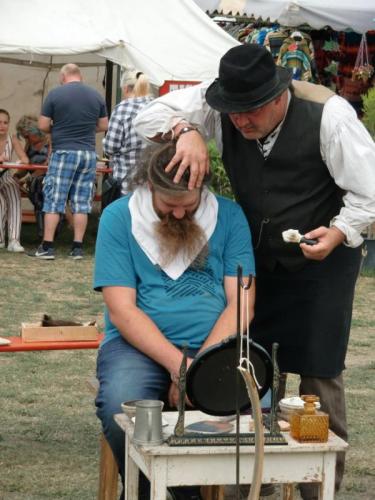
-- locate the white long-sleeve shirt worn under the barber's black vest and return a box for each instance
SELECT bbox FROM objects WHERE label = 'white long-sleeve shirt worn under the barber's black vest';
[134,82,375,247]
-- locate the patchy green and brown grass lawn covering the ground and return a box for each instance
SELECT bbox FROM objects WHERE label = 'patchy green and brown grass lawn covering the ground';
[0,218,375,500]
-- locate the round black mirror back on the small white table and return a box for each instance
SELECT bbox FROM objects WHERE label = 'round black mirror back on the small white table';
[186,336,273,416]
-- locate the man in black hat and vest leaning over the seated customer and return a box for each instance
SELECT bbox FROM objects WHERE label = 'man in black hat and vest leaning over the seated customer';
[135,45,375,500]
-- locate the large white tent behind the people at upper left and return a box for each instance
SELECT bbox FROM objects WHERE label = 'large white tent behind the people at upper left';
[0,0,238,144]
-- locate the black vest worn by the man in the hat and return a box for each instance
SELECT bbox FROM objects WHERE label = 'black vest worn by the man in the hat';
[221,96,342,270]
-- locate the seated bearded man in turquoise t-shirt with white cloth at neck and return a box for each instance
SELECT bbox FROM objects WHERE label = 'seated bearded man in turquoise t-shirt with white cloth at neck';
[94,144,255,498]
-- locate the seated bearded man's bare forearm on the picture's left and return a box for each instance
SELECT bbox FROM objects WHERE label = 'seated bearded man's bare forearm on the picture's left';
[103,286,182,374]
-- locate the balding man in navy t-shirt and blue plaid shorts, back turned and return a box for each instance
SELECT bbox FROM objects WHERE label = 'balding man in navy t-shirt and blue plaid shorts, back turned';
[31,64,108,260]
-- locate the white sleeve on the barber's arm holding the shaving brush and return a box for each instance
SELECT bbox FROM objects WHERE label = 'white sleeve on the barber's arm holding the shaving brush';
[320,96,375,247]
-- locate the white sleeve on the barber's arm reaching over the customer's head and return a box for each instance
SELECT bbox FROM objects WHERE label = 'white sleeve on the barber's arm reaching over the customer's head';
[134,81,221,150]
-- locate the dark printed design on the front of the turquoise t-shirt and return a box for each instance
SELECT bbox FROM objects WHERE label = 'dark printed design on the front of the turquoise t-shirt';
[162,267,215,297]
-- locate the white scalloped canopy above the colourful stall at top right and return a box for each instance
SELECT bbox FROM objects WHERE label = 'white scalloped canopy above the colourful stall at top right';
[195,0,375,33]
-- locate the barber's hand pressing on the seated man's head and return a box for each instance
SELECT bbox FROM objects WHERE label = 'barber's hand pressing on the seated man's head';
[165,130,210,189]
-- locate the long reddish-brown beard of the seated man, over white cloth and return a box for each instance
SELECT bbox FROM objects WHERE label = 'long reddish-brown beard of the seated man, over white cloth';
[155,214,208,268]
